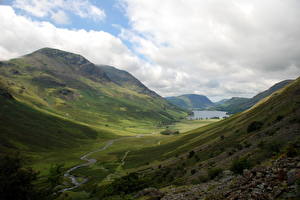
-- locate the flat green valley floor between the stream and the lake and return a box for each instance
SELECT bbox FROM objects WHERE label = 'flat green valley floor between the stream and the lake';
[33,119,218,199]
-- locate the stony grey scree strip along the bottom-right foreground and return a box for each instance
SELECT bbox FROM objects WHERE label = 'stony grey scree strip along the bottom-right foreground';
[154,157,300,200]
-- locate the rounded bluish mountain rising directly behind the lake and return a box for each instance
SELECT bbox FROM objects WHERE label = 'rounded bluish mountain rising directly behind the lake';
[166,94,214,109]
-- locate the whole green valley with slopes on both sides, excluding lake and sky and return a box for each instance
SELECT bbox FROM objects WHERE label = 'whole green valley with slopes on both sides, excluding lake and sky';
[0,48,300,200]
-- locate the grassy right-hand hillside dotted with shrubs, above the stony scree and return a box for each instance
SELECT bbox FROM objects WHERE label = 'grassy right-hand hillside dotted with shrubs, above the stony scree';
[95,78,300,197]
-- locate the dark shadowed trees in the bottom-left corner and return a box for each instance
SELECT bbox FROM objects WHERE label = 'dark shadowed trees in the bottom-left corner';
[0,153,64,200]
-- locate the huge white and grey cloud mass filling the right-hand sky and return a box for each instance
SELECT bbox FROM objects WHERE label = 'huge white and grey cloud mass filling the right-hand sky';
[120,0,300,99]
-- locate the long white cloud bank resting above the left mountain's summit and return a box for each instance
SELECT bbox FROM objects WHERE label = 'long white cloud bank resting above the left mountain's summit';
[0,6,141,73]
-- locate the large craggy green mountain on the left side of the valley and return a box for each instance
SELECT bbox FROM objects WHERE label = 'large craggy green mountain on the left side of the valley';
[0,48,185,126]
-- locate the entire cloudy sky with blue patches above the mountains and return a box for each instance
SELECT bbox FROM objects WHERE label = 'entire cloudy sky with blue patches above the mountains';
[0,0,300,101]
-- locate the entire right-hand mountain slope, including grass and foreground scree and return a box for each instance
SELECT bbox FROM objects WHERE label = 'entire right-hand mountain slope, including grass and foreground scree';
[93,77,300,200]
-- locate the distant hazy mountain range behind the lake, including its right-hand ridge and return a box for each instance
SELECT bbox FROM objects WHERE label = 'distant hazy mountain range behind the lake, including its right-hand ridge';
[166,80,293,114]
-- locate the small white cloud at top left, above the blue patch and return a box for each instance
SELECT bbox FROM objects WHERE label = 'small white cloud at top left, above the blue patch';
[13,0,105,24]
